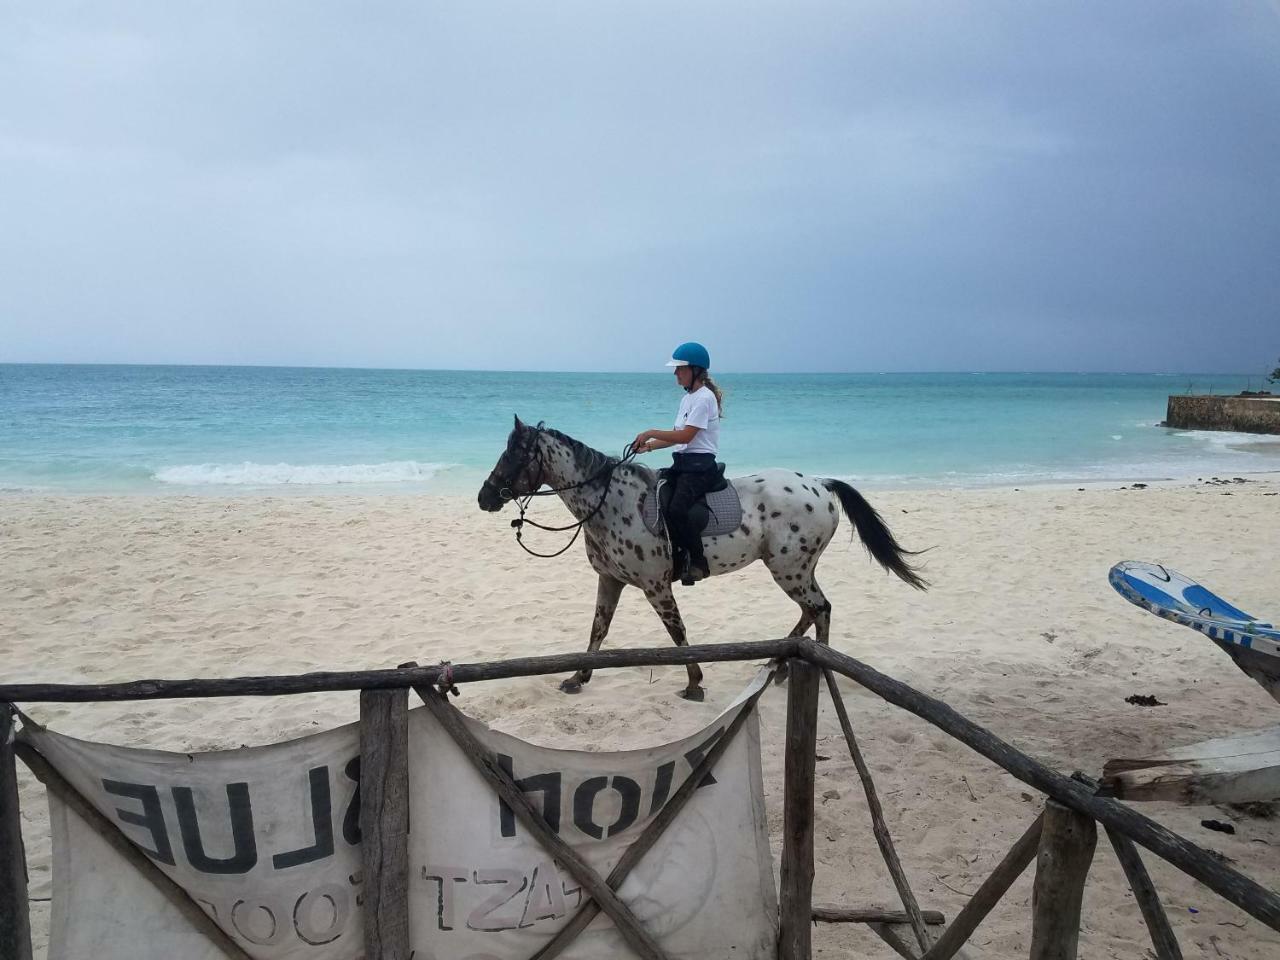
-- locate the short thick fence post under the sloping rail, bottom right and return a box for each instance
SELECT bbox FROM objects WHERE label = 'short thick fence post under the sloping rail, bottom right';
[1030,800,1098,960]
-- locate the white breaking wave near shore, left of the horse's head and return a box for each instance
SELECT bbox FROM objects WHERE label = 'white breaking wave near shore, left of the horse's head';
[152,460,457,486]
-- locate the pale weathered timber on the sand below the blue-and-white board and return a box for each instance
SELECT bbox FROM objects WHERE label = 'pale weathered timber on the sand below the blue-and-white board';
[1102,727,1280,804]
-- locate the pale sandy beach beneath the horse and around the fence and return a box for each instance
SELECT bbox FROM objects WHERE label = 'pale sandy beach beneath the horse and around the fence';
[0,479,1280,960]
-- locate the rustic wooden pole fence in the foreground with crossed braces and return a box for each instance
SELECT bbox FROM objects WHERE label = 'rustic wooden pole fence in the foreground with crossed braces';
[0,637,1280,960]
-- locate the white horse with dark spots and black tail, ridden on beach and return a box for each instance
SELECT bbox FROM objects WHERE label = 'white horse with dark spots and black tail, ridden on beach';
[477,417,927,700]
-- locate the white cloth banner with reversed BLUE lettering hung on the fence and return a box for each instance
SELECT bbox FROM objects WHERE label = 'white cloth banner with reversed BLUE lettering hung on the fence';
[24,671,777,960]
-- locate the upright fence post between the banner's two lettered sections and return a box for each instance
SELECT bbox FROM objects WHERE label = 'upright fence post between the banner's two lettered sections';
[360,689,410,960]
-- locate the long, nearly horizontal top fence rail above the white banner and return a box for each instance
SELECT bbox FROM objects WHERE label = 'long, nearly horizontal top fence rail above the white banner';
[0,637,796,703]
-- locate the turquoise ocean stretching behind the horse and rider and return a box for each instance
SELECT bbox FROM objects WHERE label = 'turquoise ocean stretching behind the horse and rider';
[0,364,1280,495]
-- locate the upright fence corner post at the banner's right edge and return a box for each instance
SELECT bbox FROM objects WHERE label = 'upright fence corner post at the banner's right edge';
[778,658,819,960]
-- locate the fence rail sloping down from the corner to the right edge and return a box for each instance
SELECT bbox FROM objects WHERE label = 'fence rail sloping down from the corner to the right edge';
[799,639,1280,931]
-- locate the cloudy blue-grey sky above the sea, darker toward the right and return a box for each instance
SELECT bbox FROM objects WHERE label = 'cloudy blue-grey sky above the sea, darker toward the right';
[0,0,1280,372]
